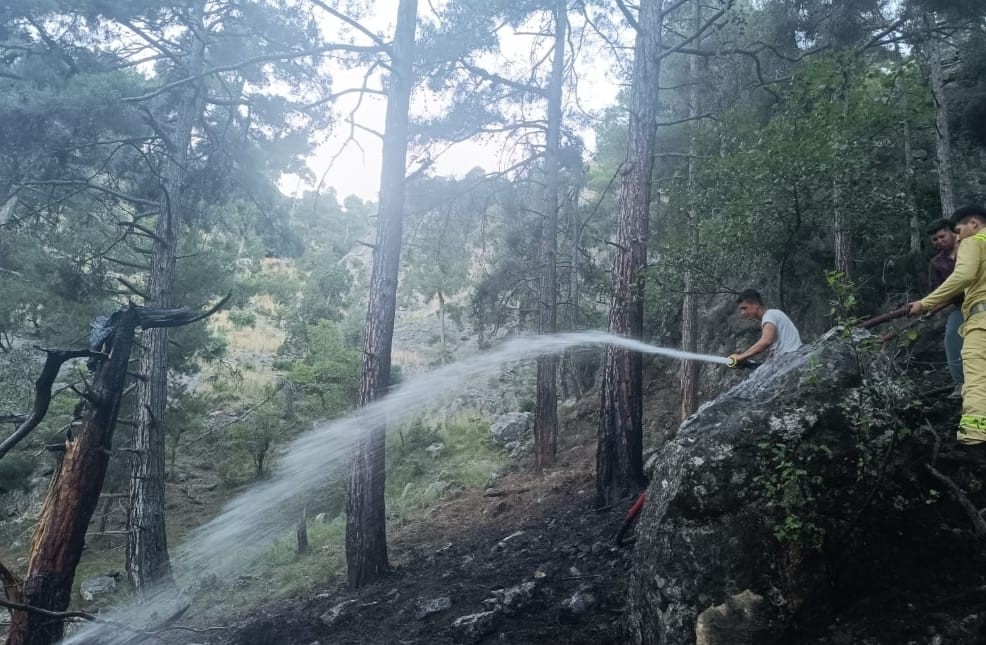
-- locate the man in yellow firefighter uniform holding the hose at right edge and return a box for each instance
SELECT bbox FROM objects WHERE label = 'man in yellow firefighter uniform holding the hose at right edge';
[909,206,986,445]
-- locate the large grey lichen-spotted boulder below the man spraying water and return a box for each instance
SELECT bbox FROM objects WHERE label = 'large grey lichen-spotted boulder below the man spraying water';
[626,341,894,645]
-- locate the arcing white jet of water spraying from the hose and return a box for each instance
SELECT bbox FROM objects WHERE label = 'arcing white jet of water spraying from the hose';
[65,332,727,643]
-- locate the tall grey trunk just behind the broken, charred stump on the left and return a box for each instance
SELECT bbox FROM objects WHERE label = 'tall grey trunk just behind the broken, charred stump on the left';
[127,15,204,595]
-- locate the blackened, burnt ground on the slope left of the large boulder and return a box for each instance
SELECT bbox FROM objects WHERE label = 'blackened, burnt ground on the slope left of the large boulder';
[218,446,630,645]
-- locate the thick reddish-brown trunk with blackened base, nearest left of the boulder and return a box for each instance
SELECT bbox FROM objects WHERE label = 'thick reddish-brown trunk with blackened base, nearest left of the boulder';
[596,0,664,506]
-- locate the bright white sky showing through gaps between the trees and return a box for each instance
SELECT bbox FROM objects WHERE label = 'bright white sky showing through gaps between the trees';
[281,0,621,201]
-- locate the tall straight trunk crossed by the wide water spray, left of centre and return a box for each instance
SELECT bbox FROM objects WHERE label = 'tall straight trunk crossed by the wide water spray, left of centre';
[346,0,418,588]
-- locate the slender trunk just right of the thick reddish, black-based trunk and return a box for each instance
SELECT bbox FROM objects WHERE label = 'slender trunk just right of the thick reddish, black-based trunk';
[681,0,702,419]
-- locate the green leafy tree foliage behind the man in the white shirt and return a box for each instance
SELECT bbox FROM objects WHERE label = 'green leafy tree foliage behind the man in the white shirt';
[649,46,937,332]
